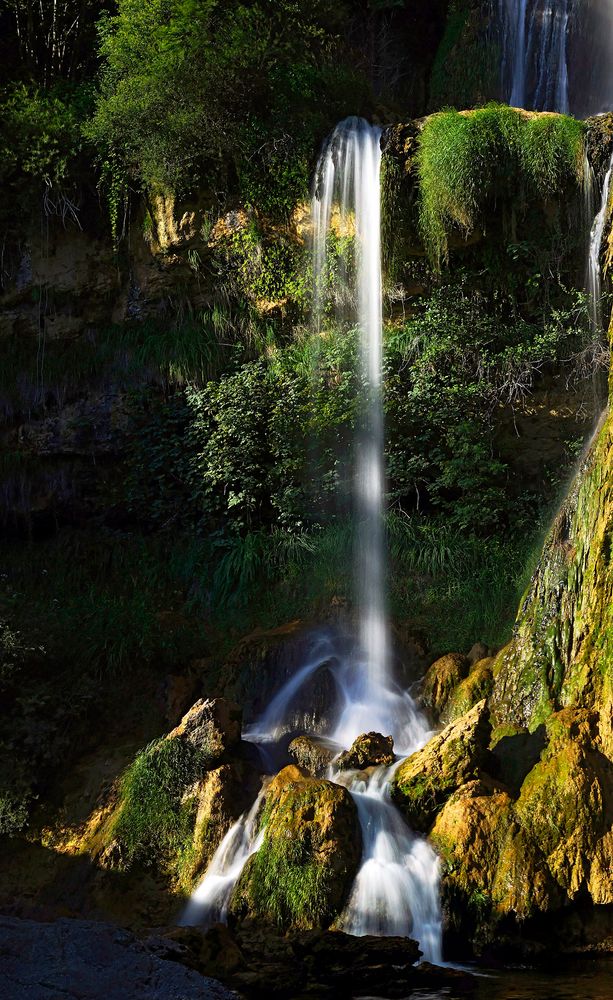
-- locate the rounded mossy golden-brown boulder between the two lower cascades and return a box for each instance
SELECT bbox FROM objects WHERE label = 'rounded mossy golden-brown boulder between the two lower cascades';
[232,766,362,929]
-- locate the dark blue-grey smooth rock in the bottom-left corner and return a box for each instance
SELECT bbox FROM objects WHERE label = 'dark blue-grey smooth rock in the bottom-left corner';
[0,917,236,1000]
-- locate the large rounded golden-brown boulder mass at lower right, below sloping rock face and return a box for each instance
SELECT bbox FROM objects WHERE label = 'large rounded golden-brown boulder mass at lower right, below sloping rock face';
[430,709,613,943]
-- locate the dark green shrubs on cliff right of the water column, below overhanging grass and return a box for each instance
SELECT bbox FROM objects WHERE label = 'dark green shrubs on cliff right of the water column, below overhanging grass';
[385,274,590,534]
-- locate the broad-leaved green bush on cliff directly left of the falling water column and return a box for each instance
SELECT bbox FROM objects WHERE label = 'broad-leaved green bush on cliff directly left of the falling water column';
[122,336,356,544]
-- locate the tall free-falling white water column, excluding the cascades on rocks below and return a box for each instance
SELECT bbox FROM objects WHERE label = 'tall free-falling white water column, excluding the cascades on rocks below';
[312,118,389,720]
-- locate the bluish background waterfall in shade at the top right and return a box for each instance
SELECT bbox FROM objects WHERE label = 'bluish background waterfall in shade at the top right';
[498,0,573,113]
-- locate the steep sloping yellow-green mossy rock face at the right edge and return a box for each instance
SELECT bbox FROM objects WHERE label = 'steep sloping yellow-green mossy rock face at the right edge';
[491,414,613,759]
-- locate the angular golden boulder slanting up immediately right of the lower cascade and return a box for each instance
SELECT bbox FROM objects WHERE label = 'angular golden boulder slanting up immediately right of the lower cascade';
[392,700,491,833]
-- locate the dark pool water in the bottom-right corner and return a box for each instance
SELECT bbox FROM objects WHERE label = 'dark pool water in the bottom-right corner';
[384,957,613,1000]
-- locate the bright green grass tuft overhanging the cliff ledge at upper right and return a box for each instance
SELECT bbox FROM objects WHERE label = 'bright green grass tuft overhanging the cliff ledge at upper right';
[417,104,585,266]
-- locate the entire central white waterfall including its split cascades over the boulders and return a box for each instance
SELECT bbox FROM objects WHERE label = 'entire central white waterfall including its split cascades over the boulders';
[182,118,442,963]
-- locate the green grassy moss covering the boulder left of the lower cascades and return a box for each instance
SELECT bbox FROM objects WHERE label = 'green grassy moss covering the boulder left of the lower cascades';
[108,737,208,872]
